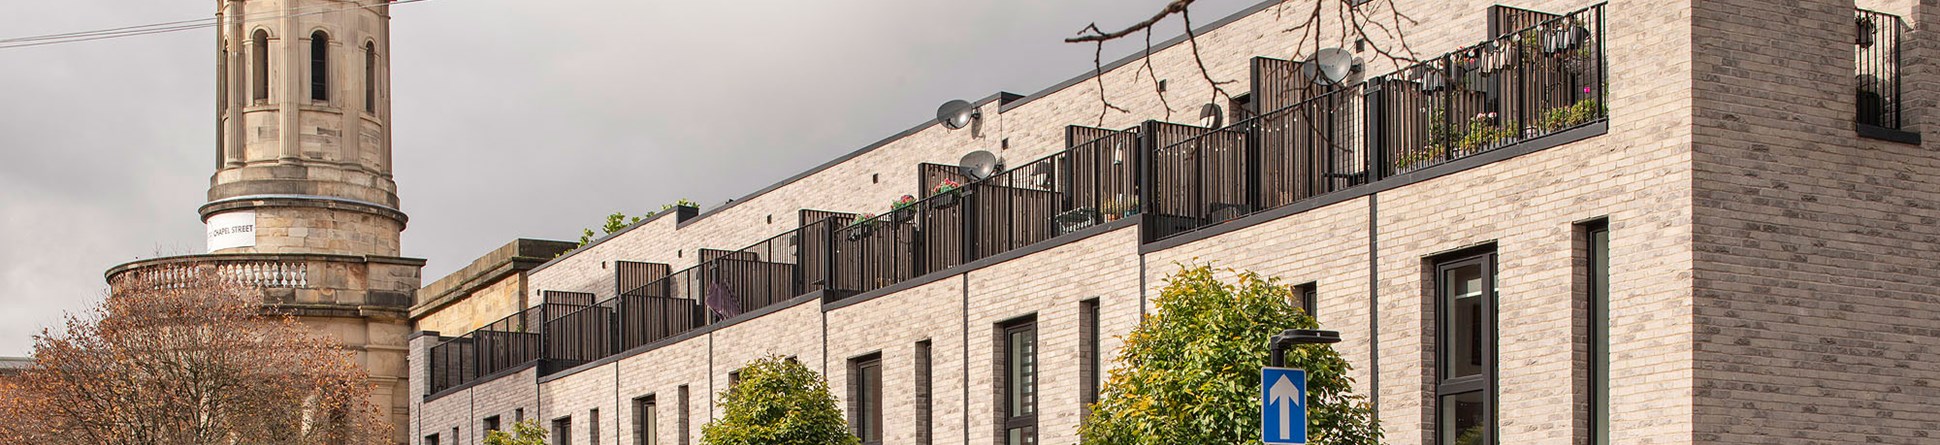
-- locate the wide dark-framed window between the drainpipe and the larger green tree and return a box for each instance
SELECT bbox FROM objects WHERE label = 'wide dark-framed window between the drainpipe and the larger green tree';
[997,319,1038,445]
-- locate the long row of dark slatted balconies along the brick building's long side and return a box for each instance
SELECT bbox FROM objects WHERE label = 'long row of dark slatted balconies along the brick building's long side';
[431,6,1606,394]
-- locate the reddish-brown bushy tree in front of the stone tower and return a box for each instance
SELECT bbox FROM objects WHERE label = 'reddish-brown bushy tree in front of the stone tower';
[0,266,388,445]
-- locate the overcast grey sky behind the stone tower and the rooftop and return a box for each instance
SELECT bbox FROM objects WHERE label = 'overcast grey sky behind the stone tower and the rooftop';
[0,0,1257,356]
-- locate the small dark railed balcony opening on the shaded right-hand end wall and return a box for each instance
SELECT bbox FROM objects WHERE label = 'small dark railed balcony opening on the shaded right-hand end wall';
[1853,10,1907,130]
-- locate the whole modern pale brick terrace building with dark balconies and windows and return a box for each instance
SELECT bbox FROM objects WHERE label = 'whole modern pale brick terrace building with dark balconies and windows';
[409,0,1940,445]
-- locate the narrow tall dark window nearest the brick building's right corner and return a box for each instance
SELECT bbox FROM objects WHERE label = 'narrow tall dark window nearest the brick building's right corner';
[1583,222,1610,445]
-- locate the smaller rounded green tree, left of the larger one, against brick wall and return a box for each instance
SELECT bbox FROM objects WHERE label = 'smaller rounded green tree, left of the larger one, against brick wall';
[700,356,861,445]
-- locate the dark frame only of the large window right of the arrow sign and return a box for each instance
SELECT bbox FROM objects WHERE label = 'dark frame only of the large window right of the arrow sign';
[1430,247,1500,445]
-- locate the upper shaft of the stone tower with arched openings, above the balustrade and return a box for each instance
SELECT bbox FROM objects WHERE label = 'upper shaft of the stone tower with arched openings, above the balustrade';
[202,0,405,257]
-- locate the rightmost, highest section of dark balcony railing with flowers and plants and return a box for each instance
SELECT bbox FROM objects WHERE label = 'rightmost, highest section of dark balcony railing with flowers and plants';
[1147,6,1606,241]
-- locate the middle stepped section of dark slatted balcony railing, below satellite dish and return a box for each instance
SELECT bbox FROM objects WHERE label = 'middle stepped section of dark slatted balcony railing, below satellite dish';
[830,130,1141,291]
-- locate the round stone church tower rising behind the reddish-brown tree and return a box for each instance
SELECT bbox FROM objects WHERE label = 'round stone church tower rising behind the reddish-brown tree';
[107,0,425,443]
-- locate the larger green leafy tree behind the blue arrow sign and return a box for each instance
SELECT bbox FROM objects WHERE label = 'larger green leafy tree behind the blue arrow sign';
[1079,266,1381,445]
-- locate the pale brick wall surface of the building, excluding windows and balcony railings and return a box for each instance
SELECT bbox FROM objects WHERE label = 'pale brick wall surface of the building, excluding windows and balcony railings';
[411,0,1940,445]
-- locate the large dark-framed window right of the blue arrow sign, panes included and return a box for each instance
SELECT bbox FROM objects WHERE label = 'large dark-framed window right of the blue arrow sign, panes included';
[1436,253,1496,445]
